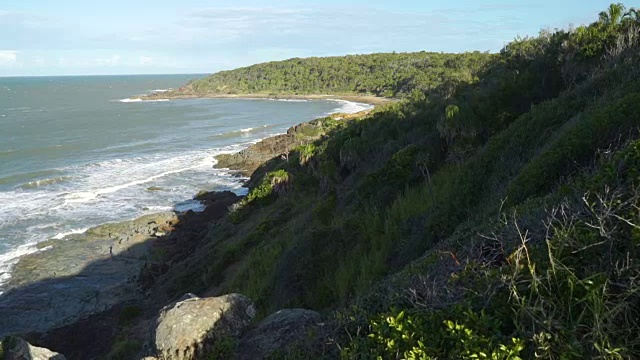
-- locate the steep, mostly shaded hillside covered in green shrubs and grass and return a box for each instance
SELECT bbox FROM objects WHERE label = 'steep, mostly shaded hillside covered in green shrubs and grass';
[141,4,640,359]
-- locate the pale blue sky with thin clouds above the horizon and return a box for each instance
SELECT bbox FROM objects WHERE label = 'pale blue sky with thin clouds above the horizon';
[0,0,611,76]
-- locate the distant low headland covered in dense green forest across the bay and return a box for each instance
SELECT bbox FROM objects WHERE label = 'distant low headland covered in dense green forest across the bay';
[180,51,494,97]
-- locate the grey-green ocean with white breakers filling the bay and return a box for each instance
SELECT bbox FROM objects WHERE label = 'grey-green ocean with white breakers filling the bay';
[0,75,368,291]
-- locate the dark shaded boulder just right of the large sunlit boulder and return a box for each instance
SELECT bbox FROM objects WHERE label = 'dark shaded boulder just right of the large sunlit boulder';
[238,309,321,359]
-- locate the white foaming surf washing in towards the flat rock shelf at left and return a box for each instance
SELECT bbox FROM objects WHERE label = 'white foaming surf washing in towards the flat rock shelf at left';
[0,98,348,288]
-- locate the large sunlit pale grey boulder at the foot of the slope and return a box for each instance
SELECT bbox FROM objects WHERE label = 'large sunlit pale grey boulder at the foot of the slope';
[151,294,255,360]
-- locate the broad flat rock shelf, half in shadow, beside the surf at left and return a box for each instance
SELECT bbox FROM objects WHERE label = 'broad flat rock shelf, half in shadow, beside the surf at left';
[0,191,239,344]
